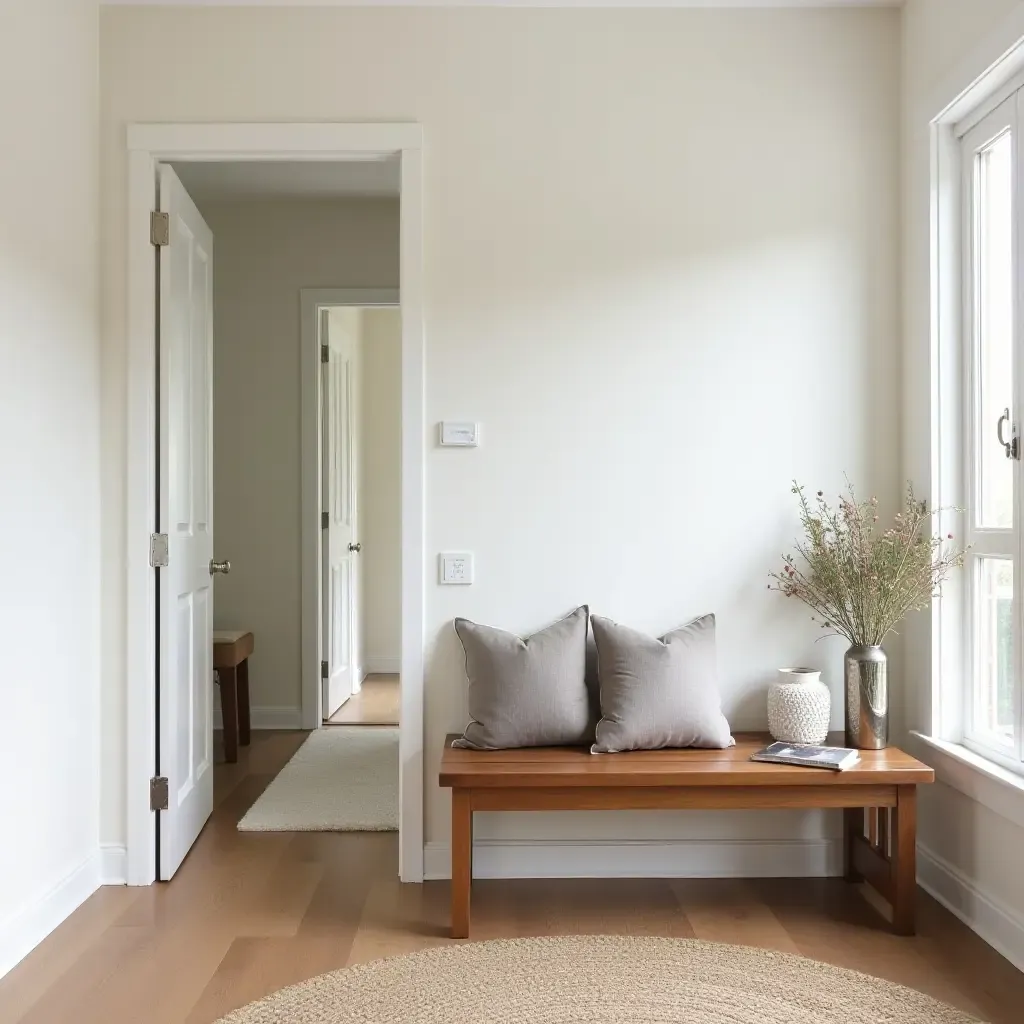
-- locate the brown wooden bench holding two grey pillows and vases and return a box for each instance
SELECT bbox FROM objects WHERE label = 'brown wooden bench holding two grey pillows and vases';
[439,733,935,938]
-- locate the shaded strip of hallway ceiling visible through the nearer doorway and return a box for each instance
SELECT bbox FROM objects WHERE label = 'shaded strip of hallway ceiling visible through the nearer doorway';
[174,158,400,204]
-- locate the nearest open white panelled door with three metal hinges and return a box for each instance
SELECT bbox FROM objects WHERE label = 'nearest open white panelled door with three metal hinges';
[157,166,213,880]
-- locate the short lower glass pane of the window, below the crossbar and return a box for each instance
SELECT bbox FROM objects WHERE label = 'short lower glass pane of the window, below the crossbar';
[974,558,1014,746]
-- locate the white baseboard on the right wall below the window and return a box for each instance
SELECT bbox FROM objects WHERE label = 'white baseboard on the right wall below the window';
[918,843,1024,971]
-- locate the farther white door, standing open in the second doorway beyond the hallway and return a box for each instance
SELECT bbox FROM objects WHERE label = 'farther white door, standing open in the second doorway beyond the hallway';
[319,309,360,718]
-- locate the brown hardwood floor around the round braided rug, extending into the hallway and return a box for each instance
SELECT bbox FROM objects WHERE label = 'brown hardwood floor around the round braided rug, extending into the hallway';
[0,732,1024,1024]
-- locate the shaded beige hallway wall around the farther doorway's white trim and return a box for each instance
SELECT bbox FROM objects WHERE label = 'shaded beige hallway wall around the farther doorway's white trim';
[203,199,398,724]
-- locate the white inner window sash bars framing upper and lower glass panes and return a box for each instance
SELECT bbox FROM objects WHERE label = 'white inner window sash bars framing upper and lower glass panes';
[955,94,1024,775]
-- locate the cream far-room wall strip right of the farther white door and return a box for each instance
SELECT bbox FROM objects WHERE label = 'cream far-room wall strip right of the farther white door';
[359,309,401,672]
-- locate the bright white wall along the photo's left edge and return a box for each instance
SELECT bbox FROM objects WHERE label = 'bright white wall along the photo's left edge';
[0,0,100,975]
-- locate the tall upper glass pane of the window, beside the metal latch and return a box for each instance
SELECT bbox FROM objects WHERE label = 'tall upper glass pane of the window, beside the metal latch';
[975,132,1014,527]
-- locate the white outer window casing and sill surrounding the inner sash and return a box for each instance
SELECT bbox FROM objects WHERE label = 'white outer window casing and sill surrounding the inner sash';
[917,5,1024,827]
